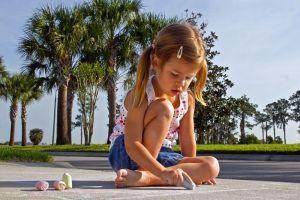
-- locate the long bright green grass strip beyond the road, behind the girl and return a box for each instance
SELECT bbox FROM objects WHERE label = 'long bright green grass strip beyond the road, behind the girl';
[0,144,300,154]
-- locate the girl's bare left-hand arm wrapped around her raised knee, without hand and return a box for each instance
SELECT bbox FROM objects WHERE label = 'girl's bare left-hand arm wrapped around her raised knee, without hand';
[124,92,165,176]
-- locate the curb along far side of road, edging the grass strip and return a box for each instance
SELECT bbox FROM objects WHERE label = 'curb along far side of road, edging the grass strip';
[47,152,300,162]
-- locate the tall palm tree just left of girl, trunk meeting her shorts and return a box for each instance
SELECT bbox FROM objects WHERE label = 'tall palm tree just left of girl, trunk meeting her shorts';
[85,0,141,143]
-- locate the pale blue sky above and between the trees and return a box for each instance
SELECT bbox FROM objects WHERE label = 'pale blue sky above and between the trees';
[0,0,300,144]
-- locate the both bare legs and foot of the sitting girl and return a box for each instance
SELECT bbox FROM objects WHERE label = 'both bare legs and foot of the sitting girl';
[115,100,219,187]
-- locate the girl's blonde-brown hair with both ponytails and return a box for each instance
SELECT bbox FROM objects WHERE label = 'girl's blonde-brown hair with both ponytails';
[133,23,207,107]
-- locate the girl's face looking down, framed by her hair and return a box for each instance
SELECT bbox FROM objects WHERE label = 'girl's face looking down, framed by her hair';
[154,56,199,97]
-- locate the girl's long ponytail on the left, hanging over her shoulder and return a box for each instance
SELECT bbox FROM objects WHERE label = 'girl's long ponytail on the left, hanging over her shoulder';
[133,46,153,107]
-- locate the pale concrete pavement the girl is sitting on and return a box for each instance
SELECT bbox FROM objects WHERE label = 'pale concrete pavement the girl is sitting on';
[0,156,300,200]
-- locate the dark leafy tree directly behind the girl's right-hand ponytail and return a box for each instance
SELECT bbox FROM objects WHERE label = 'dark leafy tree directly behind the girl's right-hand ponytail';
[185,10,236,144]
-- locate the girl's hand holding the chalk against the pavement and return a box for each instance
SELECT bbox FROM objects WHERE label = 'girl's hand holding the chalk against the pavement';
[160,169,183,186]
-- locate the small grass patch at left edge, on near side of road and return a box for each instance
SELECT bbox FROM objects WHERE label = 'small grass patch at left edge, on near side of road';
[0,146,53,162]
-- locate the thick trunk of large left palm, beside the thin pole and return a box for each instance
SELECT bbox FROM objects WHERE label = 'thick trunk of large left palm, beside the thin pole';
[56,84,70,145]
